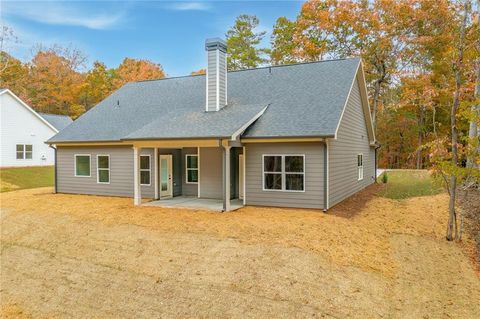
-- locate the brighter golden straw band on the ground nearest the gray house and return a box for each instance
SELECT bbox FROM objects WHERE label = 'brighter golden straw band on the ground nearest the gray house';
[0,188,448,277]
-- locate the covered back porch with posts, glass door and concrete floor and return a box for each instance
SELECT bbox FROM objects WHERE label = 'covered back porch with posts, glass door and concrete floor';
[133,139,245,211]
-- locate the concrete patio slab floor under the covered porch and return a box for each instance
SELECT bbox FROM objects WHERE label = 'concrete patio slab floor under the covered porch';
[143,196,243,212]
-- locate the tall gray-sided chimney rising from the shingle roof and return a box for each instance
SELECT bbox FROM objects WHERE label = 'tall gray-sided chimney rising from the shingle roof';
[205,38,227,112]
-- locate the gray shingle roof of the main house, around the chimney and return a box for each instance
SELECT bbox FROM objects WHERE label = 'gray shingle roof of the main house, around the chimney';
[49,58,360,143]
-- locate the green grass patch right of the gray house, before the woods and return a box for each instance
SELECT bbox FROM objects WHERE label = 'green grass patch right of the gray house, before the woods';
[378,170,444,199]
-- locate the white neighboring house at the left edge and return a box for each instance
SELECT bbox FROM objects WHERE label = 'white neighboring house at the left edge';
[0,89,72,167]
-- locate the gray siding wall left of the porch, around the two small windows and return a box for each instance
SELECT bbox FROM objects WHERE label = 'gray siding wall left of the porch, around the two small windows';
[57,146,155,198]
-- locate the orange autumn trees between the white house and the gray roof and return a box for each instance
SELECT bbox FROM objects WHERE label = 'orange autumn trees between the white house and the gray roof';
[0,46,165,118]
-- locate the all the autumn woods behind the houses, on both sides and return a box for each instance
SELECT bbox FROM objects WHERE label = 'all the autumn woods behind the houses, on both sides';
[0,0,480,176]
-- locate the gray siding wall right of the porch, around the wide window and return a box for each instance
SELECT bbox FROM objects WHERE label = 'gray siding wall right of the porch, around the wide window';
[245,143,324,208]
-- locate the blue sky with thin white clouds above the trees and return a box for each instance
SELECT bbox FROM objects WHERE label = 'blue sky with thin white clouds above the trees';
[0,0,302,76]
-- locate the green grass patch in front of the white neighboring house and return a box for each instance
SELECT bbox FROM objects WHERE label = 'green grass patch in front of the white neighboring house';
[0,166,55,193]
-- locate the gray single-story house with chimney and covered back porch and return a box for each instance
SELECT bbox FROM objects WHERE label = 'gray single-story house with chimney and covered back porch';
[48,38,376,211]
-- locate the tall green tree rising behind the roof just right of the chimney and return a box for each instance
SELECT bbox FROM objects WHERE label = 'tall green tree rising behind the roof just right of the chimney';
[226,14,269,71]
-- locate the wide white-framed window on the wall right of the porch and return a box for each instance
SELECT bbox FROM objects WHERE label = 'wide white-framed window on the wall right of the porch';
[263,155,305,192]
